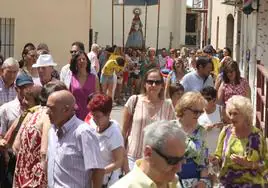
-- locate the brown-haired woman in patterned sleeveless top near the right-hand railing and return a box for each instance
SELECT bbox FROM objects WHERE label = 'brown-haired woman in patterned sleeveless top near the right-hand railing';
[218,61,250,106]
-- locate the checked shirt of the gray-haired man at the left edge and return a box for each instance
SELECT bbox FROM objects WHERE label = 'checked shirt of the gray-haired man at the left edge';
[0,77,17,106]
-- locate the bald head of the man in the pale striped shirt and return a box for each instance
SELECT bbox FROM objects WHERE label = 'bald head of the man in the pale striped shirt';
[47,90,75,127]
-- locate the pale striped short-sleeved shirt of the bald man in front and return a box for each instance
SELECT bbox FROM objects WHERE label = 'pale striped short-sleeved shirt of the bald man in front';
[48,116,104,188]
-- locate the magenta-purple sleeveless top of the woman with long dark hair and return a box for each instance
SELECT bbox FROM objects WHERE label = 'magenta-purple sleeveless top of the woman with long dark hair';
[70,74,96,121]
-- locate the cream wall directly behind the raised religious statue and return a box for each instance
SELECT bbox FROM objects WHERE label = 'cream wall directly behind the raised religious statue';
[92,0,186,48]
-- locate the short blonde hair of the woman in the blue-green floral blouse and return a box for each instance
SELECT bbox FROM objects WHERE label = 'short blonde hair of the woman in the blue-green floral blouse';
[175,92,207,117]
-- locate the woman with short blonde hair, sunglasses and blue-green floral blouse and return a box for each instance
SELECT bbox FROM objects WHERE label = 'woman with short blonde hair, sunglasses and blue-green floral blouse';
[175,92,211,188]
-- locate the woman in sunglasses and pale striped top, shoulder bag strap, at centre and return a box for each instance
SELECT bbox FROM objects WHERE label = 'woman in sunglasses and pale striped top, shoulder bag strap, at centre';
[122,69,175,171]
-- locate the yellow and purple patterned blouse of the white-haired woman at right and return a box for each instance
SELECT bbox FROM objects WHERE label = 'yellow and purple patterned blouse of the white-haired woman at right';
[215,125,268,188]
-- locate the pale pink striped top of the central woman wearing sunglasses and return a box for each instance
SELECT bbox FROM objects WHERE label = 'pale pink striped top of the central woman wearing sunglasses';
[125,95,175,159]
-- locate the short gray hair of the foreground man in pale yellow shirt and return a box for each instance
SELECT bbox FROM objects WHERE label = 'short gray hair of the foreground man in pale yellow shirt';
[143,120,186,151]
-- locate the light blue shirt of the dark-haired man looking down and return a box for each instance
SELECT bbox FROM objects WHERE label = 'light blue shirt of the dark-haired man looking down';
[181,71,214,92]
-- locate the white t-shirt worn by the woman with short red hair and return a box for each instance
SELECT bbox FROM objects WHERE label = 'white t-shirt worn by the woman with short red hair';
[90,118,124,186]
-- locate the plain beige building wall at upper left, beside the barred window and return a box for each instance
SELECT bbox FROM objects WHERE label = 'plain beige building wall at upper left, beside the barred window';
[0,0,89,69]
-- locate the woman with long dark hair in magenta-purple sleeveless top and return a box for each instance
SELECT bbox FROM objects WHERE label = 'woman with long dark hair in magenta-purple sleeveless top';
[61,52,99,120]
